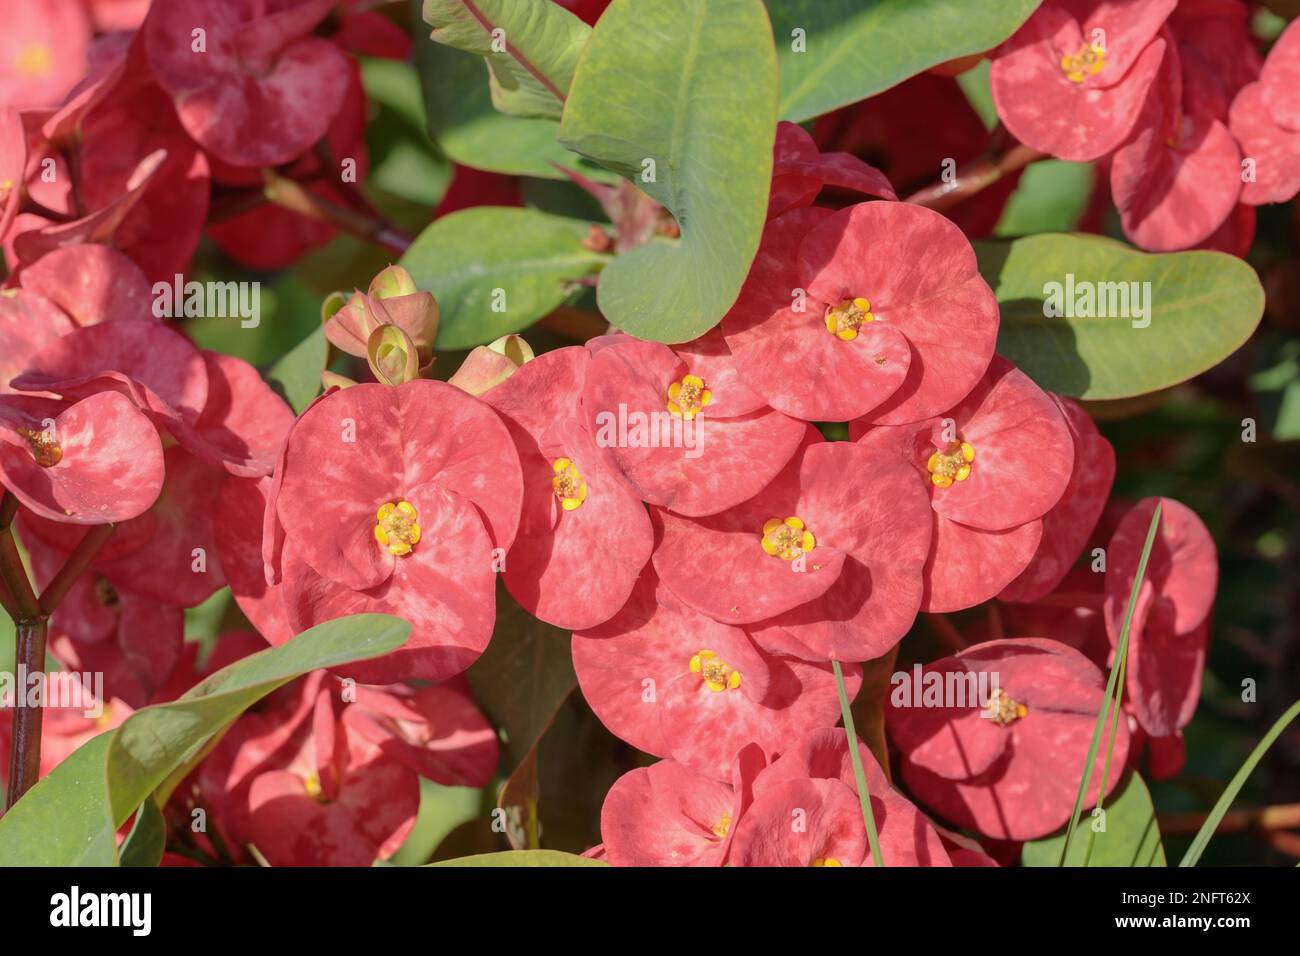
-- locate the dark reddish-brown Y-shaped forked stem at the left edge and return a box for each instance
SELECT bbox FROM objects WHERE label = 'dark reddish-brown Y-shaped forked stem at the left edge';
[0,492,113,809]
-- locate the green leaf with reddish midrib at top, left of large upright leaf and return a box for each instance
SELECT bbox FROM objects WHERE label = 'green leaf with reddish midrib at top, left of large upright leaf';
[424,0,592,120]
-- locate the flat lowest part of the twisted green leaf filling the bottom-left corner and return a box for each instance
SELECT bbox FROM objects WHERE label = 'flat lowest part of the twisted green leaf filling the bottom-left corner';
[0,732,117,866]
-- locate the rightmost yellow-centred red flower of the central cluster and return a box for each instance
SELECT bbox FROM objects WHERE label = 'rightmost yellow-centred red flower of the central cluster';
[850,356,1074,611]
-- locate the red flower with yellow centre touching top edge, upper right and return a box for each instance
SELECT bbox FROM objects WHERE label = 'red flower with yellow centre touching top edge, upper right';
[989,0,1177,163]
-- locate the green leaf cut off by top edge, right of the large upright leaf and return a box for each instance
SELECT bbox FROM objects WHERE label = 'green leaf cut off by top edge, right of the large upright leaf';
[767,0,1041,121]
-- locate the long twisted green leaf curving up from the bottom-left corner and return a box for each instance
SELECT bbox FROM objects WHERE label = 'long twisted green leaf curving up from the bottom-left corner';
[0,614,411,866]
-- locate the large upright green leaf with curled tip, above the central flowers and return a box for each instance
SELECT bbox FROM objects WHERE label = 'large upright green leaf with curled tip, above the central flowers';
[560,0,776,342]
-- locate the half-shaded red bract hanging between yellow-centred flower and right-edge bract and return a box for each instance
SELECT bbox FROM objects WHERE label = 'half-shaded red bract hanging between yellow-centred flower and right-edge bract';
[1110,29,1242,251]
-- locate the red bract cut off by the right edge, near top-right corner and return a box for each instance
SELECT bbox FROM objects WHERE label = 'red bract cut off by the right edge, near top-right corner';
[1230,23,1300,206]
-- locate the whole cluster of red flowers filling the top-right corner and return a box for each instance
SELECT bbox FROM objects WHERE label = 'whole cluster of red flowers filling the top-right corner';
[991,0,1300,255]
